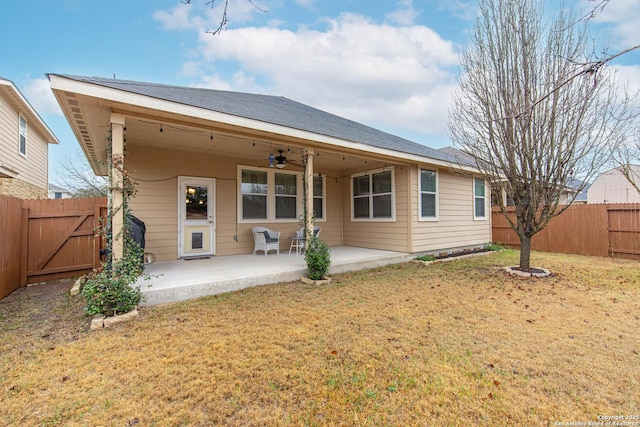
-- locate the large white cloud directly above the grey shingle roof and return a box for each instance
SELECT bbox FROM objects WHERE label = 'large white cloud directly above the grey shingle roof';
[178,11,458,145]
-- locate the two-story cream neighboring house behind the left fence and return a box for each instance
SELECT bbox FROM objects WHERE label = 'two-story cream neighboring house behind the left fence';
[0,77,59,199]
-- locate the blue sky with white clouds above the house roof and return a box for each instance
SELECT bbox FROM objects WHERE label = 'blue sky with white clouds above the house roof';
[0,0,640,183]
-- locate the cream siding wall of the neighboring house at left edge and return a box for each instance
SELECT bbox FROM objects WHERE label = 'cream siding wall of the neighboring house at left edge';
[0,96,49,191]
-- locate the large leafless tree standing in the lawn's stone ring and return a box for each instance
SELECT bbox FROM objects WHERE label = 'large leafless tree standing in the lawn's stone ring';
[449,0,630,271]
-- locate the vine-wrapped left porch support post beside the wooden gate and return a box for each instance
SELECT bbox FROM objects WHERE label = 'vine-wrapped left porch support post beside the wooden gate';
[109,113,125,261]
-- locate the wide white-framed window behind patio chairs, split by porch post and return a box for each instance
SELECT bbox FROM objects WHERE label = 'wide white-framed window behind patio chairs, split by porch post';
[238,167,325,222]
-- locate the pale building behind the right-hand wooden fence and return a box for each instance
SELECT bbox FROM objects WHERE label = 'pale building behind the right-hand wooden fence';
[587,165,640,203]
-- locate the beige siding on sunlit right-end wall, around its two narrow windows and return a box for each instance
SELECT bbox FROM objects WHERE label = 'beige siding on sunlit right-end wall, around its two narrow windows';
[411,167,491,252]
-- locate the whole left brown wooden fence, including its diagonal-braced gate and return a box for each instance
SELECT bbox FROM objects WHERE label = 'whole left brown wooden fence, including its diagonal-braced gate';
[0,195,107,298]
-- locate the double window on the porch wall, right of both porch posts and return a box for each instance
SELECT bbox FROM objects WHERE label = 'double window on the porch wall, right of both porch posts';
[351,170,394,219]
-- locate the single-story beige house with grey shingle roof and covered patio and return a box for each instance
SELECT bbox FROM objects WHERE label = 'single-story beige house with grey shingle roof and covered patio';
[49,74,491,261]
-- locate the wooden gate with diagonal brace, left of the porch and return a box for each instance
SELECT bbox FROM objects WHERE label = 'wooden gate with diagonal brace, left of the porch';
[21,198,106,285]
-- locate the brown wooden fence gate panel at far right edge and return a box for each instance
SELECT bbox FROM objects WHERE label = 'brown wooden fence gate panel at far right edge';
[607,204,640,260]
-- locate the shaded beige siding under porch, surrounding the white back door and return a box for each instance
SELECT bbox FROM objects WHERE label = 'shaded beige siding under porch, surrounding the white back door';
[126,144,342,261]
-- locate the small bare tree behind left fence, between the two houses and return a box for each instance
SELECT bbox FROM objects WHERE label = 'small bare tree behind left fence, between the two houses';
[56,153,108,197]
